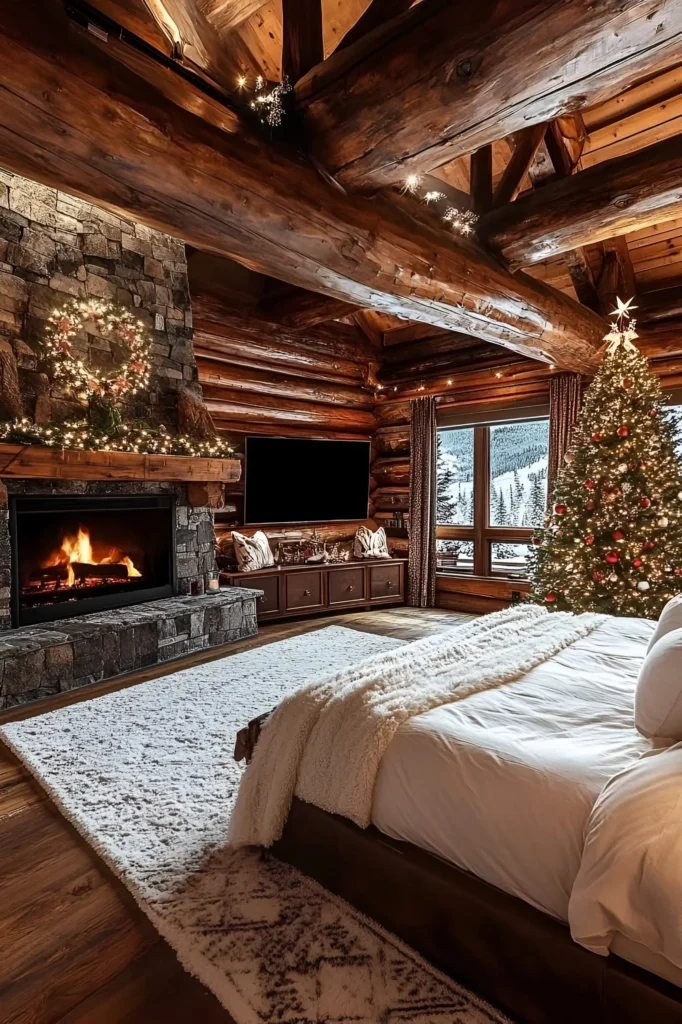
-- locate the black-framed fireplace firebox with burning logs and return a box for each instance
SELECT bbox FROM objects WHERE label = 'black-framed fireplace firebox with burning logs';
[9,495,176,626]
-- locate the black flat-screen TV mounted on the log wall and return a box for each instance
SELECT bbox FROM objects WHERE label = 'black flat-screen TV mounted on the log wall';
[244,437,370,525]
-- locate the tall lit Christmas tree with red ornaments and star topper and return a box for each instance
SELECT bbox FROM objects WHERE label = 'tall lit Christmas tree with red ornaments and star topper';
[531,300,682,618]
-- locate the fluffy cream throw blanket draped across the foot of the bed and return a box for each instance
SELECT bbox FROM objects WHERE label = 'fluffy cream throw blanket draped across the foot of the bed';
[229,605,605,847]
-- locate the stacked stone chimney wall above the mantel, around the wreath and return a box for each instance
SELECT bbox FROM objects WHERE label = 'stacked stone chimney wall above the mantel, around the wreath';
[0,170,201,429]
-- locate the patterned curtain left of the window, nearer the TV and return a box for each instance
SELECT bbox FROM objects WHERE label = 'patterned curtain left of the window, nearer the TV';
[408,397,436,608]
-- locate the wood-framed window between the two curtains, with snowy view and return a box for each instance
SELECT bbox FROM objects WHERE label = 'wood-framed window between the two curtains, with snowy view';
[436,420,549,578]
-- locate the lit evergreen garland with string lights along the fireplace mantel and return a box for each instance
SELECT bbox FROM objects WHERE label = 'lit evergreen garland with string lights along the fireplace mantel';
[0,417,235,459]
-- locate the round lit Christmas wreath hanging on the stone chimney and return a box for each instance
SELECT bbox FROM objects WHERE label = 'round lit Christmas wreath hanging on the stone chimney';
[45,299,151,398]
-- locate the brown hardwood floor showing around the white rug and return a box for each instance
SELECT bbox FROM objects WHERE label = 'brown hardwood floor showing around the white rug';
[0,607,469,1024]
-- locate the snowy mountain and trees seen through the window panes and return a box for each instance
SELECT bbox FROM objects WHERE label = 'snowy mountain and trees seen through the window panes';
[437,420,549,571]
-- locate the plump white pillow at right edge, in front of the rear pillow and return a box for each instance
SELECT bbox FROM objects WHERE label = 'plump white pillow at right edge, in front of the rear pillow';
[635,629,682,740]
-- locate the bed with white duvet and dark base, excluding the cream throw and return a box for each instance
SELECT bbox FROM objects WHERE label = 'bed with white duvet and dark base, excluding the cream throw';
[231,616,682,1024]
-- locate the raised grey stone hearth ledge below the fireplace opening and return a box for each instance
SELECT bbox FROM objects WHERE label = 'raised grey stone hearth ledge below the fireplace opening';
[0,587,262,709]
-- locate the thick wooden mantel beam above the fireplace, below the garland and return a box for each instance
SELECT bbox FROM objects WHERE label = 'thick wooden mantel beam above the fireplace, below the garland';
[0,444,242,483]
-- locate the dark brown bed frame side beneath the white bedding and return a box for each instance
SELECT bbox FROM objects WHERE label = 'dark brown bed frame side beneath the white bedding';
[272,800,682,1024]
